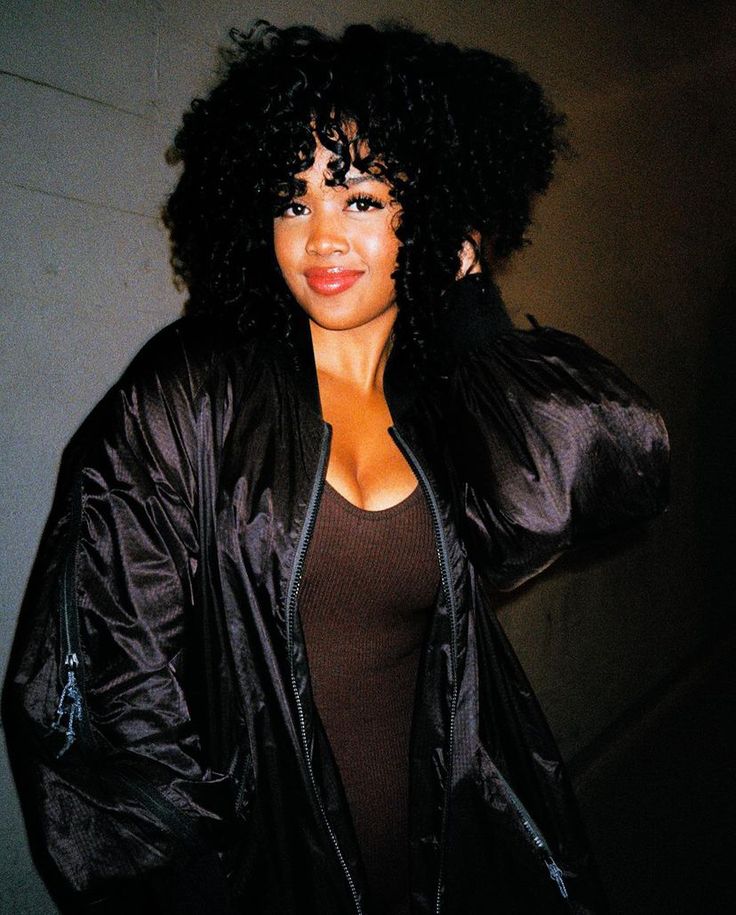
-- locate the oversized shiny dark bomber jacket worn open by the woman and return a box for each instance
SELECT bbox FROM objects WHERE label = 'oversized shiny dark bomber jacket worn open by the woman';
[4,278,668,915]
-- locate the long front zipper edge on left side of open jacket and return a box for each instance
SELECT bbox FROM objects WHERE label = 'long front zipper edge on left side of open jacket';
[286,423,363,915]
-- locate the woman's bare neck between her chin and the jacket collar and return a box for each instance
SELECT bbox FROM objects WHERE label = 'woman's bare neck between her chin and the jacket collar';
[309,308,396,392]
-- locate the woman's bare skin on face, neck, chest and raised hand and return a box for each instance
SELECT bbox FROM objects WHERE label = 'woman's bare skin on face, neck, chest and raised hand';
[274,143,480,511]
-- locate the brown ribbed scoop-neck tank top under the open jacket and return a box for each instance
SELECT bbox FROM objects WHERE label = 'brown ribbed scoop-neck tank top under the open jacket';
[299,483,440,915]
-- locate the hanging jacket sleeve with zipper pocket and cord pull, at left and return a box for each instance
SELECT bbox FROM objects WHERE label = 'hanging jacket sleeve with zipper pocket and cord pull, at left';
[3,325,232,912]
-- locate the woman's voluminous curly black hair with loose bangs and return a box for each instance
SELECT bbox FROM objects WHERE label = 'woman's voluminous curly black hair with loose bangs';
[163,20,567,368]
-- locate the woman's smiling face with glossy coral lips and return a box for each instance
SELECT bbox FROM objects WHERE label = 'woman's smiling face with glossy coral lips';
[274,142,400,330]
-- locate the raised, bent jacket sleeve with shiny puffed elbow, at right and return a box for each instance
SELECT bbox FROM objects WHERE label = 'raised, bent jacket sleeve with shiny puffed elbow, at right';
[446,276,669,590]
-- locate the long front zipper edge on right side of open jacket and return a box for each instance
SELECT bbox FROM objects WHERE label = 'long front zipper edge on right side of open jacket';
[388,426,458,915]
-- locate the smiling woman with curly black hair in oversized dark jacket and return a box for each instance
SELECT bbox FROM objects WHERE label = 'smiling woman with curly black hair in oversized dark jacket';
[5,24,667,915]
